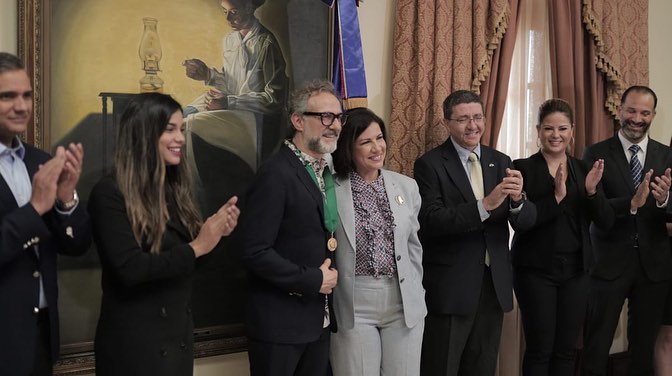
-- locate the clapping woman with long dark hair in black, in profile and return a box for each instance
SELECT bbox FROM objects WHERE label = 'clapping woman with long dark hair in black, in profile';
[89,93,239,375]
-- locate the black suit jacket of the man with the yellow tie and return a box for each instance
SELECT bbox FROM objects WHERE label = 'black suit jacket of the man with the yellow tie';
[415,138,535,315]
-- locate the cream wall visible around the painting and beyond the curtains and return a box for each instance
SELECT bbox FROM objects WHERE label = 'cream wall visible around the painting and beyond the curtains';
[0,0,672,376]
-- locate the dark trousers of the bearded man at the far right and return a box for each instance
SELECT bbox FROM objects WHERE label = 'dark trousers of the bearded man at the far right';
[582,252,669,375]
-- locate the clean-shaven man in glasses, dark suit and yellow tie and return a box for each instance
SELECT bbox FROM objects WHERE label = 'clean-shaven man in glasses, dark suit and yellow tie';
[415,90,536,376]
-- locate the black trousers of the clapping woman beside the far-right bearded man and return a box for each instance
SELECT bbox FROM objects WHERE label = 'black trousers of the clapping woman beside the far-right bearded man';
[513,254,588,376]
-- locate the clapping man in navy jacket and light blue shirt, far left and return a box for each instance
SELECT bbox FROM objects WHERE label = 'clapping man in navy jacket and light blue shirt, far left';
[0,52,91,375]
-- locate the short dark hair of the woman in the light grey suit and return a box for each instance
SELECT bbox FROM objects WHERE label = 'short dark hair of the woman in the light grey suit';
[331,107,387,177]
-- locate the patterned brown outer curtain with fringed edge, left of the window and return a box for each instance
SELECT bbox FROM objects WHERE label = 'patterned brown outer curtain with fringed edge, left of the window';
[388,0,511,175]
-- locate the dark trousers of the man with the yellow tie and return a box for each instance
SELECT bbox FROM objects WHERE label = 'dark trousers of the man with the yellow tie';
[420,267,504,376]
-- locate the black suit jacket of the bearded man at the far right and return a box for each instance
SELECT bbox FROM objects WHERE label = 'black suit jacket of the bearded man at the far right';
[583,135,672,282]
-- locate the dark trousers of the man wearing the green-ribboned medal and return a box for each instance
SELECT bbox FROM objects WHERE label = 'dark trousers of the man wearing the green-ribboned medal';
[248,328,331,376]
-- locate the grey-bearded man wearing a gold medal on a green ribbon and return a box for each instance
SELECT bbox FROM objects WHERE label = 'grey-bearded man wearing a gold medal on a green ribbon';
[240,81,346,376]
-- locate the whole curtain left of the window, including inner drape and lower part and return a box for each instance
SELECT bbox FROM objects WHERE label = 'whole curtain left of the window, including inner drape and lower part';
[388,0,522,376]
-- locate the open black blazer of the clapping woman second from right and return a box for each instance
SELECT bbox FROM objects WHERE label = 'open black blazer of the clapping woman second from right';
[511,152,613,271]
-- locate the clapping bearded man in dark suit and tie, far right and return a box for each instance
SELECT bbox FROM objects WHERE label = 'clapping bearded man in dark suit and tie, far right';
[583,86,672,375]
